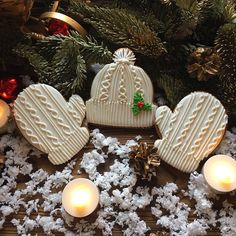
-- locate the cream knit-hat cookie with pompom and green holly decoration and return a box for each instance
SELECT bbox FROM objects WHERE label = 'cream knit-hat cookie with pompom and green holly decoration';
[86,48,156,127]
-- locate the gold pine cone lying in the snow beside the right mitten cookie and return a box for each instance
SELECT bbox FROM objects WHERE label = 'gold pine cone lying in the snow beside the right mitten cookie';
[129,142,161,178]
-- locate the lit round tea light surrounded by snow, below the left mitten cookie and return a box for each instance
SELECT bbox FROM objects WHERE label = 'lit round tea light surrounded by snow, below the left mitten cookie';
[62,178,99,217]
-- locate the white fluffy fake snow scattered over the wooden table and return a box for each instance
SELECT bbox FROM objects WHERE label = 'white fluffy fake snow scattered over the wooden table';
[0,129,236,236]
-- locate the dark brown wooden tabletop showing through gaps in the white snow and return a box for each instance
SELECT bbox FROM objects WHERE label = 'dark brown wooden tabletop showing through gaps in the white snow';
[0,126,236,236]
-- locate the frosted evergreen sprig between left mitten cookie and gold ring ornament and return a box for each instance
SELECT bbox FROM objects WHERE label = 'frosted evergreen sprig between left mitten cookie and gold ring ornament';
[15,32,112,97]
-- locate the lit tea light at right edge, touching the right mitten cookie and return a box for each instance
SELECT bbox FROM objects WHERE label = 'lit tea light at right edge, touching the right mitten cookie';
[203,155,236,192]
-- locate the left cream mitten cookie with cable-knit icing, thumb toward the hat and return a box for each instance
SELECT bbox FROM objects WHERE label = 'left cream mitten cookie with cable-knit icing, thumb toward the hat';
[14,84,89,165]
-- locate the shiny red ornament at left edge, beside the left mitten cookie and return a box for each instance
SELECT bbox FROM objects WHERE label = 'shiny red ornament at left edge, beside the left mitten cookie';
[0,76,18,99]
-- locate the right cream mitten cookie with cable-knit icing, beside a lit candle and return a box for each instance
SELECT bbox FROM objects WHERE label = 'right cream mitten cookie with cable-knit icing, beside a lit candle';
[155,92,228,172]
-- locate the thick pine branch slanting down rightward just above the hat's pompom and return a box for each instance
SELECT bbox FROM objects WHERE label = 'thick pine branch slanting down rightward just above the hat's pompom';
[70,1,166,58]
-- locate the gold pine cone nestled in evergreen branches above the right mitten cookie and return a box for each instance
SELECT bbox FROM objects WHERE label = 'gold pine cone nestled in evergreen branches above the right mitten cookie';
[187,47,220,81]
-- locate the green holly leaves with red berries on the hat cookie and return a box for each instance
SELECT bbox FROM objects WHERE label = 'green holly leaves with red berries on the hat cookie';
[132,92,152,116]
